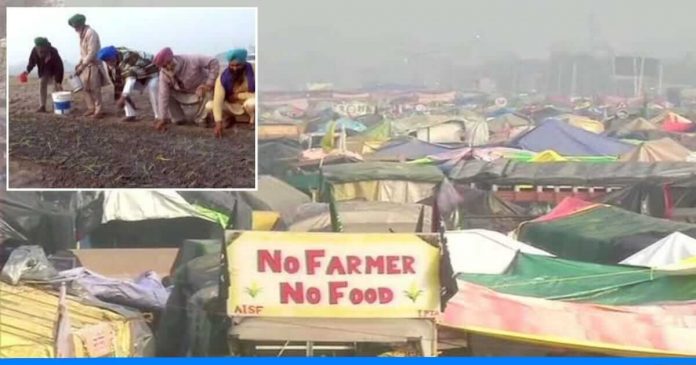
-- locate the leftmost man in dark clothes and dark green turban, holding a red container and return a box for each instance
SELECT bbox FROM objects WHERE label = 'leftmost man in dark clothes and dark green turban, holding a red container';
[22,37,63,113]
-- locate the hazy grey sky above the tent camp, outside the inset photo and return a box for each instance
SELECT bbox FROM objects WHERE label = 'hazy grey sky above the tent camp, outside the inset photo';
[7,0,696,86]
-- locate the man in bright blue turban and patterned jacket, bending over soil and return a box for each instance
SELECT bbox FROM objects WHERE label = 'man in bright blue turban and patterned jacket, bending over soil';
[97,46,160,122]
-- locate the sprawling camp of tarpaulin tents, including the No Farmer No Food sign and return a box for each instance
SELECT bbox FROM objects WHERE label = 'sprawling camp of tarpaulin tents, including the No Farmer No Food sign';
[6,88,696,357]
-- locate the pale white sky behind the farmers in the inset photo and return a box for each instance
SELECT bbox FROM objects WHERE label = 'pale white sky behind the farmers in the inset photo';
[7,8,256,64]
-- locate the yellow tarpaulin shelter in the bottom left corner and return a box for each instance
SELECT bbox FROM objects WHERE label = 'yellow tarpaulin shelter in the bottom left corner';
[0,282,139,358]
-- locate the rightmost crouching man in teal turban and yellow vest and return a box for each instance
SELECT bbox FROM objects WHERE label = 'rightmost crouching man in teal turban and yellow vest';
[206,48,256,138]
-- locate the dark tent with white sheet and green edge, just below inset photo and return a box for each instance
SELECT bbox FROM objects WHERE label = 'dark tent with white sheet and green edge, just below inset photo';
[77,190,251,248]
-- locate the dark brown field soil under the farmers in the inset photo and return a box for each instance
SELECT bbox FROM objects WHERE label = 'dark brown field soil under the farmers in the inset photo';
[3,75,256,189]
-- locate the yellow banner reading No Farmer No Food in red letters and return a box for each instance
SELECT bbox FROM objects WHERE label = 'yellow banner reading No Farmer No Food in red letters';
[227,232,440,318]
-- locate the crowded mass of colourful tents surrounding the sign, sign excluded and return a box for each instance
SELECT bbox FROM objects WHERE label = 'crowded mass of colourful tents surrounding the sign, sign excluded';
[0,93,696,356]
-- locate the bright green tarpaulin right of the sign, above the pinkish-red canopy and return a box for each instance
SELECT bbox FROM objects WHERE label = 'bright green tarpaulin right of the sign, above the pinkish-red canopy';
[457,253,696,305]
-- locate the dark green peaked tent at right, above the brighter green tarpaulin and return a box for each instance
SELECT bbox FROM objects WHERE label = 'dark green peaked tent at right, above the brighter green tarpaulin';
[517,204,696,264]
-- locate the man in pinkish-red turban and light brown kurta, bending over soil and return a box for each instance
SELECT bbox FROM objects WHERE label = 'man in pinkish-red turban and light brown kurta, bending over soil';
[154,47,220,131]
